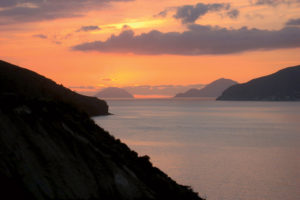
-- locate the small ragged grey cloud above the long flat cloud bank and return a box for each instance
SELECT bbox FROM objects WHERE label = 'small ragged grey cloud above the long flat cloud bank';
[155,3,239,24]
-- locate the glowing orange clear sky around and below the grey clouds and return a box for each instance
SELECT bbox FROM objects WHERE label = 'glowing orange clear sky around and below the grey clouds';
[0,0,300,93]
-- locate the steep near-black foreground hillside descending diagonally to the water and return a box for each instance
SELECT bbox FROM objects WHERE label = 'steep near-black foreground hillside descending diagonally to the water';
[0,60,201,200]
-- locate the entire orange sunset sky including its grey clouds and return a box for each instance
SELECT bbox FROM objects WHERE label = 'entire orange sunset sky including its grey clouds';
[0,0,300,95]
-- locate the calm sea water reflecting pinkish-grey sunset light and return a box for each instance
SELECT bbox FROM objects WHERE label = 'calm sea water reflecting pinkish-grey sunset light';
[94,99,300,200]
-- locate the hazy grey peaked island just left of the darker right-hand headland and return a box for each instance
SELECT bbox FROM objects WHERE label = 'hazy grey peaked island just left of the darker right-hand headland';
[175,78,237,98]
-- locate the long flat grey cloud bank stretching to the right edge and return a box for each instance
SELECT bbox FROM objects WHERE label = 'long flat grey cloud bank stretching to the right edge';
[72,24,300,55]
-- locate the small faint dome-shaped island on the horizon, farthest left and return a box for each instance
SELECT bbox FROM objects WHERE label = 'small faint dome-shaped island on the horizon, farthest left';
[95,87,134,99]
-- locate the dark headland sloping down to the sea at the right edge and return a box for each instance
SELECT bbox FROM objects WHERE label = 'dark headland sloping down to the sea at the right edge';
[217,65,300,101]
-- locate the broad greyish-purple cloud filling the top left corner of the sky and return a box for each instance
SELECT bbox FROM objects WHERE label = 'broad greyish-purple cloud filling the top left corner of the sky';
[0,0,131,24]
